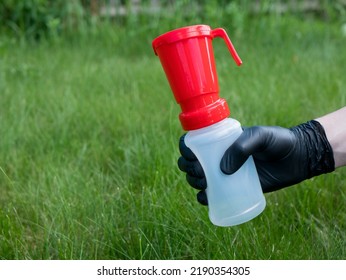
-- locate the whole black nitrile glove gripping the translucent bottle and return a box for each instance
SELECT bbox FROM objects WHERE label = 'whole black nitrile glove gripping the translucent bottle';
[178,120,335,205]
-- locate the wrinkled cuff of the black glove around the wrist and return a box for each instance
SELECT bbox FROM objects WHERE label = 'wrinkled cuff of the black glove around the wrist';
[291,120,335,179]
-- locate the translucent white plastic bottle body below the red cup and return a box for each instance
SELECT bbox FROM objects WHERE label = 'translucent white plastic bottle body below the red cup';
[185,118,266,226]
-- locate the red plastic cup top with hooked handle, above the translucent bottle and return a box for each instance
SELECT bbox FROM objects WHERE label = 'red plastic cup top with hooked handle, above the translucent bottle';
[152,25,242,130]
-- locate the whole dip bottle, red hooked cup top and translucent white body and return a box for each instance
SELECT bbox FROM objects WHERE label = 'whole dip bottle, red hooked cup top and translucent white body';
[152,25,265,226]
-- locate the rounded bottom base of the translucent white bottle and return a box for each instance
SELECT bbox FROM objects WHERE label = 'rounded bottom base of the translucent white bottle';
[209,199,266,227]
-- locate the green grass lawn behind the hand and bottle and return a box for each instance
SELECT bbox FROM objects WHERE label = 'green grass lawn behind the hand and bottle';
[0,15,346,259]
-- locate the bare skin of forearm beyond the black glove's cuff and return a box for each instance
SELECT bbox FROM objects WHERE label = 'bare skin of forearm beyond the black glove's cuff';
[316,107,346,168]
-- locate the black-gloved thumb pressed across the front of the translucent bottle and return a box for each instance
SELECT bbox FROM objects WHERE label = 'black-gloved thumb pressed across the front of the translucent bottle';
[220,126,266,175]
